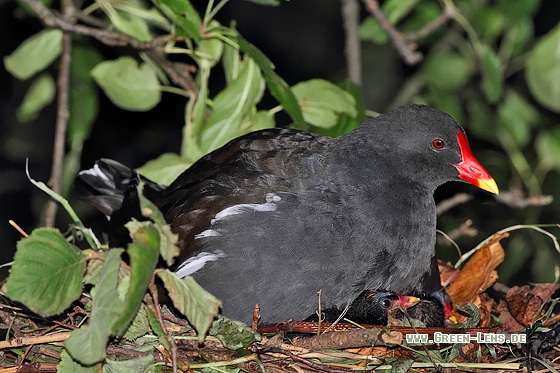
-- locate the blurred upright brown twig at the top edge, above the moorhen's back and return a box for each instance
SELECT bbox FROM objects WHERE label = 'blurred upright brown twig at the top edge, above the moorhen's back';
[342,0,362,86]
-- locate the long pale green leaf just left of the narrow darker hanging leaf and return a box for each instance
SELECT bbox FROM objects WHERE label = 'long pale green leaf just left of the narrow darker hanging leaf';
[64,249,123,365]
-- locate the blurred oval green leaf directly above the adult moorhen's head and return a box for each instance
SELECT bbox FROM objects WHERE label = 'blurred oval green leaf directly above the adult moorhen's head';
[420,51,471,91]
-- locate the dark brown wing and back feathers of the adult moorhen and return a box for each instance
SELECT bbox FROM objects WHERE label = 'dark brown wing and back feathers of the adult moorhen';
[156,129,328,262]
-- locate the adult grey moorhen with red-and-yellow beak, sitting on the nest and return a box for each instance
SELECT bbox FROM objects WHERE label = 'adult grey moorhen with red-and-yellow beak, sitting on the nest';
[76,105,498,322]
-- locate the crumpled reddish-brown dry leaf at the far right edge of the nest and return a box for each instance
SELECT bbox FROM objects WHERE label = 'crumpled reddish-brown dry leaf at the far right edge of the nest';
[506,284,560,326]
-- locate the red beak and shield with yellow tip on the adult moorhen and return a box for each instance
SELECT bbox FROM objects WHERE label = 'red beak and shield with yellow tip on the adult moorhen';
[455,131,500,194]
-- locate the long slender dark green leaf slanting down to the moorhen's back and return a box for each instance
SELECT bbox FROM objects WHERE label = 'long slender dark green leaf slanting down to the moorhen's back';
[237,35,306,128]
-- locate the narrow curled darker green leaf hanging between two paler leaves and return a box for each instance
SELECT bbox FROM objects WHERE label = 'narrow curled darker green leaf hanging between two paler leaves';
[113,220,160,336]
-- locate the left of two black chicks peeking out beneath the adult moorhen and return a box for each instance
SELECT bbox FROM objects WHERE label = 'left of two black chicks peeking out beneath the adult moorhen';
[305,290,420,325]
